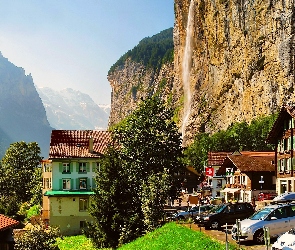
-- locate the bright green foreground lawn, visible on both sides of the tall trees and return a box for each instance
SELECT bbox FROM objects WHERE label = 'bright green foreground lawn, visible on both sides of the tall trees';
[58,222,236,250]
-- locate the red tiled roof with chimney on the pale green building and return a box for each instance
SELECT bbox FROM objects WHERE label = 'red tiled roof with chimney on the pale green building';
[49,130,111,159]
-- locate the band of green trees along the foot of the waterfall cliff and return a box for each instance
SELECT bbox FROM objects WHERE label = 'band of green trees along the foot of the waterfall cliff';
[184,114,277,172]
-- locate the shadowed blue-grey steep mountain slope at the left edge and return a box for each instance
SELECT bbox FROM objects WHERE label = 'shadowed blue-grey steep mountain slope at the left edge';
[0,53,52,158]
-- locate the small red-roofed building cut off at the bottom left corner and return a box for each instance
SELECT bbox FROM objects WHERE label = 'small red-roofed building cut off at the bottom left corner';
[0,214,19,250]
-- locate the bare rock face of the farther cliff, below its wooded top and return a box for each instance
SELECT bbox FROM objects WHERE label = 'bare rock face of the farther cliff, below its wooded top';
[108,59,174,125]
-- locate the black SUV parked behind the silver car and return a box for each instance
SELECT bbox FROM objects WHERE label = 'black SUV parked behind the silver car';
[195,202,255,229]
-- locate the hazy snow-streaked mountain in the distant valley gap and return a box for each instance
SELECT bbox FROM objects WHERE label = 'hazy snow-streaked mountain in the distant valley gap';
[36,87,110,130]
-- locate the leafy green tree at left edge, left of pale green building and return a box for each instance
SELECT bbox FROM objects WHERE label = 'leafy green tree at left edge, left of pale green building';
[0,141,42,215]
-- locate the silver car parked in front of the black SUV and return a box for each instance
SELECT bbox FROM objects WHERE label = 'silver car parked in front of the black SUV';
[232,203,295,244]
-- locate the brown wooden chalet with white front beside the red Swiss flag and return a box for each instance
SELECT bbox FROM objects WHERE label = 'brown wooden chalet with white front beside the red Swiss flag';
[217,151,276,202]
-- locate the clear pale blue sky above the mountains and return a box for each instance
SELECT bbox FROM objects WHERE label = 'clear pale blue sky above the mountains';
[0,0,174,104]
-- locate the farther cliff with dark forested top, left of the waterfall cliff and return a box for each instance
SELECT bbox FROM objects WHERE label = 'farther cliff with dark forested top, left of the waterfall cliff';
[108,28,174,126]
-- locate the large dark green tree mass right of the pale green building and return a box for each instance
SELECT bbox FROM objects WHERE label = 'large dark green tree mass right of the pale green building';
[88,96,183,247]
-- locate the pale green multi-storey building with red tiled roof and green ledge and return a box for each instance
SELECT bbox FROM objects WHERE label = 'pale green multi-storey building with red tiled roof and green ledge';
[42,130,110,235]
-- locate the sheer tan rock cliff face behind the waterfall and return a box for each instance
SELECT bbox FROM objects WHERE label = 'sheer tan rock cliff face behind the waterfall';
[174,0,295,146]
